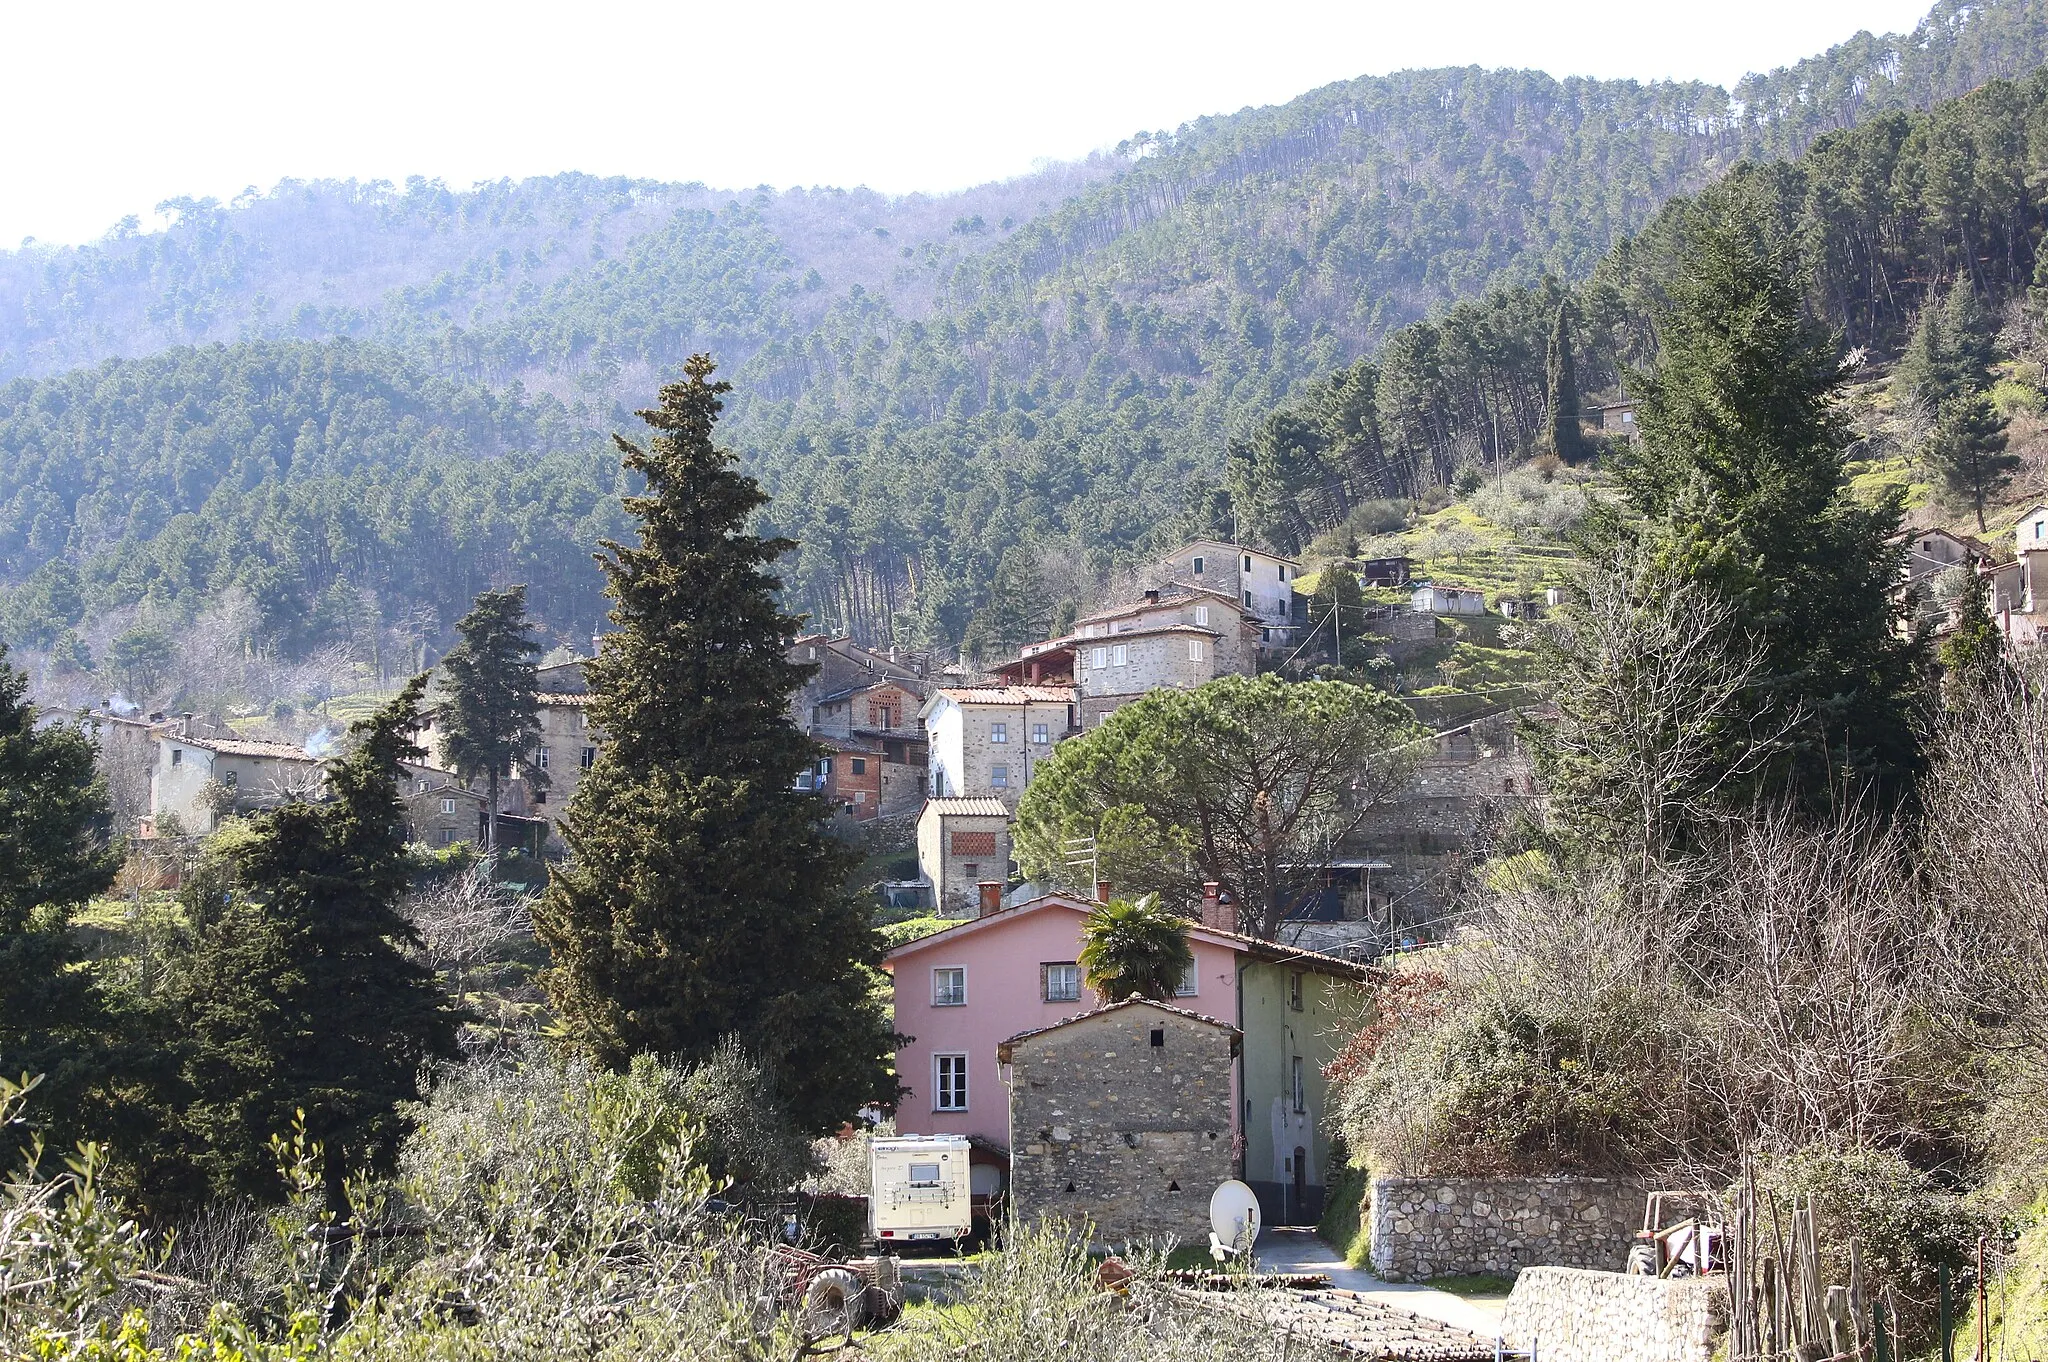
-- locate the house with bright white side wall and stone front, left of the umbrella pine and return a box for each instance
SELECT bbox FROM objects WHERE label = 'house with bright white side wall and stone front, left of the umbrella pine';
[918,686,1077,811]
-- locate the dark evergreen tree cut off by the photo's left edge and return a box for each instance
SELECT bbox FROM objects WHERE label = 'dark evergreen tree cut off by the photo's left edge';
[0,647,119,1163]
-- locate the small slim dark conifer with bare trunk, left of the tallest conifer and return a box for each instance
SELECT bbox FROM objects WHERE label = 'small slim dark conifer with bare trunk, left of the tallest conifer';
[434,586,547,848]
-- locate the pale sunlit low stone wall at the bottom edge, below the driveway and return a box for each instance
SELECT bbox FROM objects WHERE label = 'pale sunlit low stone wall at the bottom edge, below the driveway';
[1501,1268,1729,1362]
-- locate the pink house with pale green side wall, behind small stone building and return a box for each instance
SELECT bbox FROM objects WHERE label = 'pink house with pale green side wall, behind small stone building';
[885,885,1372,1223]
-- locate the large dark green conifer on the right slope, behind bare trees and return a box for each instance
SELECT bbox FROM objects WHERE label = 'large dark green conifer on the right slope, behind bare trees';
[1589,211,1921,807]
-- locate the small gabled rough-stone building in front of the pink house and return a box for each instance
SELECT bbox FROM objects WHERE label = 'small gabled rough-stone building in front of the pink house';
[995,997,1239,1245]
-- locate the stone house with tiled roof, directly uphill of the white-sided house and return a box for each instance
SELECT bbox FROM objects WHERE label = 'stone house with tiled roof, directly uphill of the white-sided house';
[1071,586,1264,727]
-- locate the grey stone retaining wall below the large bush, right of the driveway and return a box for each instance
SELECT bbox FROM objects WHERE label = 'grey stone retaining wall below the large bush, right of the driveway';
[1366,1178,1645,1278]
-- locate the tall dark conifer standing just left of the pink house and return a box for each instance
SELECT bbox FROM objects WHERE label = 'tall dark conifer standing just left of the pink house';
[535,354,895,1131]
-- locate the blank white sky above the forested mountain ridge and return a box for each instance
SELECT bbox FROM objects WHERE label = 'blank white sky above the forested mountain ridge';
[0,0,1927,246]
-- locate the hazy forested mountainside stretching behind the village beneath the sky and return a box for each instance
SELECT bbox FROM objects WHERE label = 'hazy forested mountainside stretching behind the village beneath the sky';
[0,0,2048,653]
